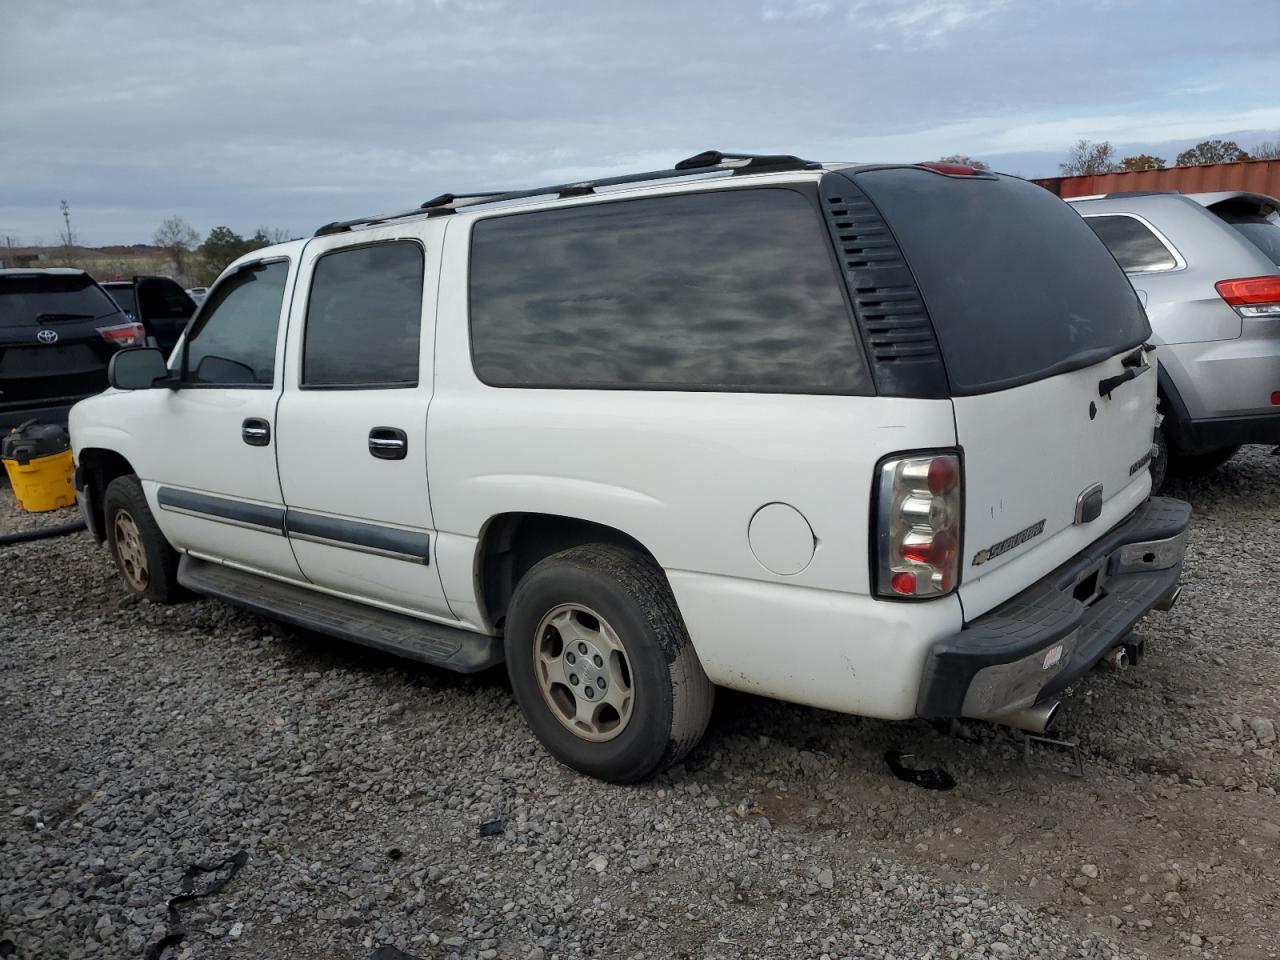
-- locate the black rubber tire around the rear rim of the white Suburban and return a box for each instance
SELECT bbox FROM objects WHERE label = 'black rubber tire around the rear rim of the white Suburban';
[506,544,716,783]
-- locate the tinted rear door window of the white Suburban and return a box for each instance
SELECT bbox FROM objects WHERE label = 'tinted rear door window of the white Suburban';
[302,241,425,388]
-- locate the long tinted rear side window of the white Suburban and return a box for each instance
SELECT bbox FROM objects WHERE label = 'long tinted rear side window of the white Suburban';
[471,189,872,394]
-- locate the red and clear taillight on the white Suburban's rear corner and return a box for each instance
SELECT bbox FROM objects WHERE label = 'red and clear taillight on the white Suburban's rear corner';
[876,452,963,599]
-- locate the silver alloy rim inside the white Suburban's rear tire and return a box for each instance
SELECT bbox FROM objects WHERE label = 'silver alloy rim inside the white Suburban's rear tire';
[534,603,635,742]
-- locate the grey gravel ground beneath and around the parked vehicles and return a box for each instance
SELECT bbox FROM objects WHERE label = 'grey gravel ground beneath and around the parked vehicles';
[0,447,1280,960]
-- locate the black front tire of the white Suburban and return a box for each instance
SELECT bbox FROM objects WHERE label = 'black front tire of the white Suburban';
[102,474,184,603]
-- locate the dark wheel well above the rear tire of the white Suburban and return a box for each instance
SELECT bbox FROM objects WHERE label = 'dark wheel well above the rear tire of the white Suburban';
[475,512,660,630]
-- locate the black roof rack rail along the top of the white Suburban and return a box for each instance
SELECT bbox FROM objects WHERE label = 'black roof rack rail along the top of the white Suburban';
[315,150,822,237]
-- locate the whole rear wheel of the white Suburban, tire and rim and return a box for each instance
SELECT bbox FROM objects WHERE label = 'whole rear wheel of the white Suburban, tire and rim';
[506,544,716,783]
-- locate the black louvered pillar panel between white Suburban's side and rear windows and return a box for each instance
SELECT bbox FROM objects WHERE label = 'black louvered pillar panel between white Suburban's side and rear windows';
[820,172,950,399]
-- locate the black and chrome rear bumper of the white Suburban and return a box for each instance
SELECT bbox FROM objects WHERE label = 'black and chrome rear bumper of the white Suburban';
[916,497,1192,721]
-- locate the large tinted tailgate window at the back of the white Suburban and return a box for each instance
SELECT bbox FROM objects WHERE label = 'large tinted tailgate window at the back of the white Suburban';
[854,168,1151,394]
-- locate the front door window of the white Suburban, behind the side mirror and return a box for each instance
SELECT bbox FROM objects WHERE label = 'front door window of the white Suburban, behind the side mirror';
[184,260,289,387]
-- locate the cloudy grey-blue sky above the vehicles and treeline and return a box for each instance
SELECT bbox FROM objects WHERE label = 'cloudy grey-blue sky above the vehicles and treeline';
[0,0,1280,244]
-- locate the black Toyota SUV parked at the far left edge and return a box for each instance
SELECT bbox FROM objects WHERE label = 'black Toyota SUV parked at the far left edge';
[0,269,146,433]
